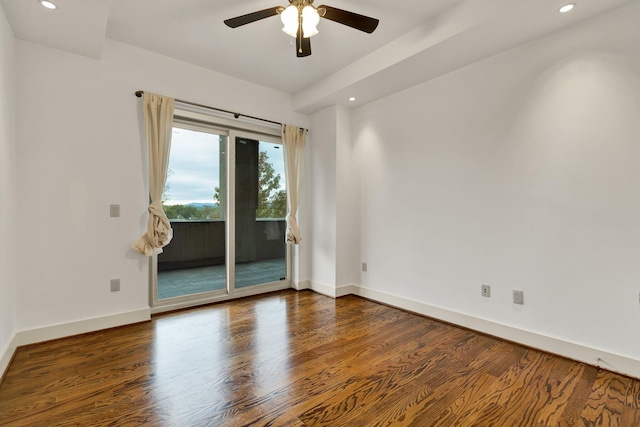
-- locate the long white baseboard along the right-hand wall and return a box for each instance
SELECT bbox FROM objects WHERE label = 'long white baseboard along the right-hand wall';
[350,285,640,379]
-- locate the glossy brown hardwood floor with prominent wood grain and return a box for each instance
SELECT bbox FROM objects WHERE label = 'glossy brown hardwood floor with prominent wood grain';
[0,291,640,427]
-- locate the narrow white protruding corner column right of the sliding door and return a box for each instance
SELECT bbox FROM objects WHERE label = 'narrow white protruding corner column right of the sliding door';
[308,106,360,296]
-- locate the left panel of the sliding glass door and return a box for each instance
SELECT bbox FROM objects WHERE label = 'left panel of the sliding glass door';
[156,127,228,301]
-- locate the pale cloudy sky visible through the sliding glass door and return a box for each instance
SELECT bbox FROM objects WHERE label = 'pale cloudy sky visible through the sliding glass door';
[165,128,285,205]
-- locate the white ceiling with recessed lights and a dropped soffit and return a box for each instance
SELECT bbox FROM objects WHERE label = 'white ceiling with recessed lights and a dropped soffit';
[0,0,633,112]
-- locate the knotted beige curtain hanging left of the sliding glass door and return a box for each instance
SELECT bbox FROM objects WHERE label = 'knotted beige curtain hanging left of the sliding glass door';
[131,92,174,256]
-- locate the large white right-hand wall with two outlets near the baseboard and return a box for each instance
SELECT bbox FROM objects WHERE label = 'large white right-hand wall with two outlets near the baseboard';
[353,2,640,362]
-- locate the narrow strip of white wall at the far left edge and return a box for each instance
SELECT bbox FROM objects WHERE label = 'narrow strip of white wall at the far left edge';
[0,2,17,377]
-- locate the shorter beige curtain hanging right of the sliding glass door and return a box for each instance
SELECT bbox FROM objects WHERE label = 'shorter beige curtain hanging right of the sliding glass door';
[282,125,307,245]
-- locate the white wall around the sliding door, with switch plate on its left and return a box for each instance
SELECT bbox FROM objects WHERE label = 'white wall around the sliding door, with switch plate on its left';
[16,40,308,330]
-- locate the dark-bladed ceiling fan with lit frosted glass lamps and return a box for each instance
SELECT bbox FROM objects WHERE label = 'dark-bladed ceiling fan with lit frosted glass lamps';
[224,0,380,58]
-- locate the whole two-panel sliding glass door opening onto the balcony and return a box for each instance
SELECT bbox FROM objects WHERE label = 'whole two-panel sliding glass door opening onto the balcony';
[151,123,289,308]
